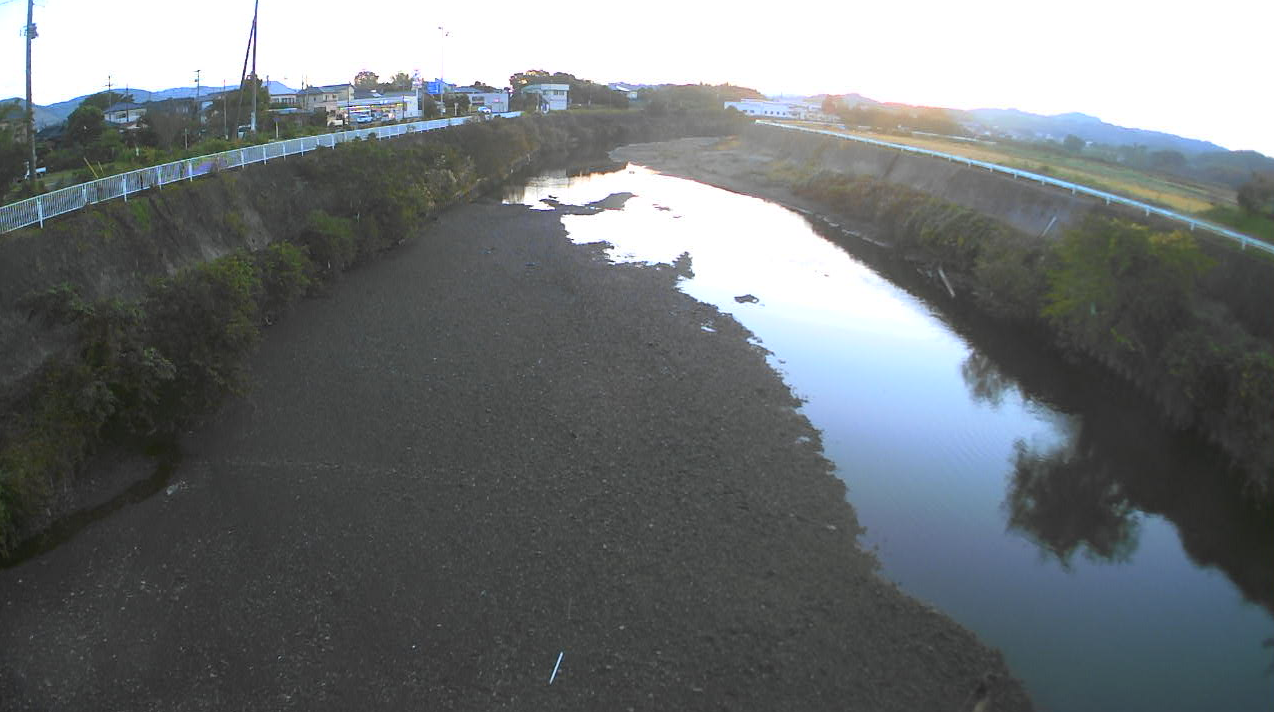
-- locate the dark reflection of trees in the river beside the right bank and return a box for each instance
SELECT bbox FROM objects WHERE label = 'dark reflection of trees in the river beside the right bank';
[961,343,1274,614]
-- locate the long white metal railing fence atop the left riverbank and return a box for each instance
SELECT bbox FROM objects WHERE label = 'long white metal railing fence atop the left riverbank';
[0,111,522,233]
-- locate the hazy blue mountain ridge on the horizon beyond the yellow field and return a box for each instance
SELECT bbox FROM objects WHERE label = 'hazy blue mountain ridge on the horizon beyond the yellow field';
[954,108,1226,155]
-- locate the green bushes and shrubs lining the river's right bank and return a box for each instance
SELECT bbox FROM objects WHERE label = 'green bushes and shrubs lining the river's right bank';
[771,166,1274,495]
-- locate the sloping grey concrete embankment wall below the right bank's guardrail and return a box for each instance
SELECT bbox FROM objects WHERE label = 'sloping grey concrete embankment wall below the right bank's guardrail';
[744,125,1108,236]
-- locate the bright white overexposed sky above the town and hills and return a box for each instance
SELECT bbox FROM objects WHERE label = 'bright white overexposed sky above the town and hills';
[0,0,1274,157]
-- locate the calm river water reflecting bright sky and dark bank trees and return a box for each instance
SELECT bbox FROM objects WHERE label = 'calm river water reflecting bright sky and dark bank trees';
[506,164,1274,712]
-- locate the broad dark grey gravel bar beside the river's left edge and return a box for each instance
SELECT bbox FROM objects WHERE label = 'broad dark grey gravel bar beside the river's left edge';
[0,196,1028,711]
